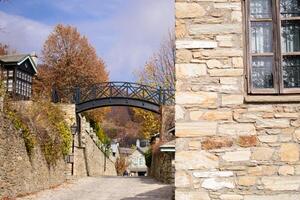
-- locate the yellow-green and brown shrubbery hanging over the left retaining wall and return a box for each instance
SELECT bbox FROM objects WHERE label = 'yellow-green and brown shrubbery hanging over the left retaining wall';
[5,100,72,167]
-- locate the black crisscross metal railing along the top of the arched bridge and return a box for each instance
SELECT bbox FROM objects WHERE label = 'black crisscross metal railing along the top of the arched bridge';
[52,82,175,105]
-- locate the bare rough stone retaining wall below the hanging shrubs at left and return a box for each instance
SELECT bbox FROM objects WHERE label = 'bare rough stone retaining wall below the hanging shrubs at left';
[0,112,67,199]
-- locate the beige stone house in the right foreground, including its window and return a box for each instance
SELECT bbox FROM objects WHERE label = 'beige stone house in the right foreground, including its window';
[175,0,300,200]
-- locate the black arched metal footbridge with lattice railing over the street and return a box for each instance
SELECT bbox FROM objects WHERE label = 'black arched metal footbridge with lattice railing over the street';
[52,82,175,113]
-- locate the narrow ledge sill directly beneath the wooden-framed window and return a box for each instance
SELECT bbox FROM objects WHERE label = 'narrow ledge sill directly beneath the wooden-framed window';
[244,95,300,103]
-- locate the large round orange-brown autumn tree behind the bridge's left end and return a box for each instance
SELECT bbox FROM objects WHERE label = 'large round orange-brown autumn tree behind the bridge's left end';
[36,24,108,98]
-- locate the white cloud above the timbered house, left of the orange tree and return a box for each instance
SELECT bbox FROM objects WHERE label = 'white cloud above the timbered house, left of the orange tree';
[0,11,51,53]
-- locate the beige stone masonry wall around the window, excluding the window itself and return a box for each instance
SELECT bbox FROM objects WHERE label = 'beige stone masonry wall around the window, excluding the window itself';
[175,0,300,200]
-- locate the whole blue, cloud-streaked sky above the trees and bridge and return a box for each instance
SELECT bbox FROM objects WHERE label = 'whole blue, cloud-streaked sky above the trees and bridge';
[0,0,174,81]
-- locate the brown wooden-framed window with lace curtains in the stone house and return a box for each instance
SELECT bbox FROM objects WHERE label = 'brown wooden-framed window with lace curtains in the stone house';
[245,0,300,94]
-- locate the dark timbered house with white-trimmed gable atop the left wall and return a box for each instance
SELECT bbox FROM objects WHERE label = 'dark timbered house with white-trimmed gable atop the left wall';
[0,53,37,100]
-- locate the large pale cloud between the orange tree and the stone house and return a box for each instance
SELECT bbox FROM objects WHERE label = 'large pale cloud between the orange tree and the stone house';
[79,0,174,80]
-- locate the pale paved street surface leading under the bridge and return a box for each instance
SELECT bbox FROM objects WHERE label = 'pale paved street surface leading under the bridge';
[18,177,172,200]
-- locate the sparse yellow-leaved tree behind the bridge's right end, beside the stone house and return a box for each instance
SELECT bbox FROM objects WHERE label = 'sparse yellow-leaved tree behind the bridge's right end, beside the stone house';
[133,33,176,138]
